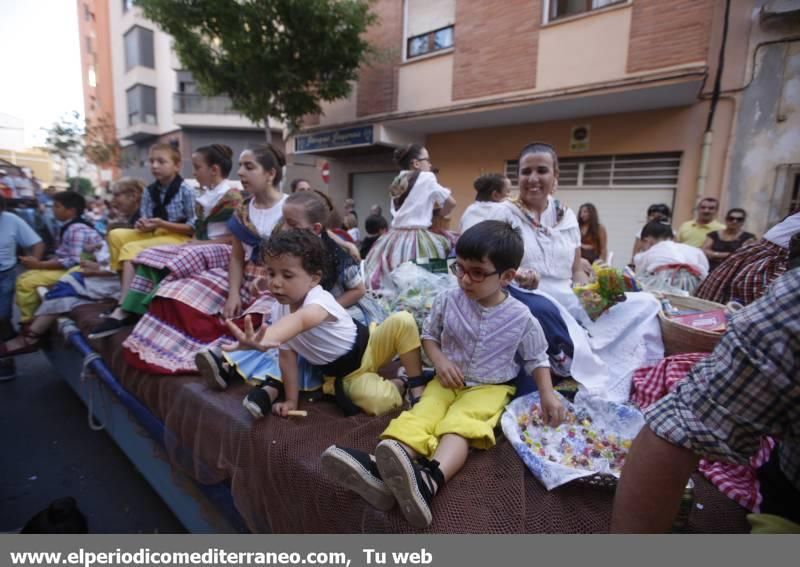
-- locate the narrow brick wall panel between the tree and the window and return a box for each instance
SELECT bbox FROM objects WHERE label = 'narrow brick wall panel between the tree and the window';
[356,0,403,116]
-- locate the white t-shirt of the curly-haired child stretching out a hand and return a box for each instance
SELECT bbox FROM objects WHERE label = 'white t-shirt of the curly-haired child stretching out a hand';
[272,285,356,366]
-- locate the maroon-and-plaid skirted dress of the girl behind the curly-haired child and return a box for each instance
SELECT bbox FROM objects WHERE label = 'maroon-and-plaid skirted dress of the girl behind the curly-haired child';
[123,197,285,375]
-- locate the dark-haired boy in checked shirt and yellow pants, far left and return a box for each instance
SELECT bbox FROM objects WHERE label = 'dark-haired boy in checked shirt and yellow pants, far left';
[16,191,103,325]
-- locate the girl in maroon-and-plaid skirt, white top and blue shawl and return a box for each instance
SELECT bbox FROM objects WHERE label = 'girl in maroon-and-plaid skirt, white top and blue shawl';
[124,145,286,374]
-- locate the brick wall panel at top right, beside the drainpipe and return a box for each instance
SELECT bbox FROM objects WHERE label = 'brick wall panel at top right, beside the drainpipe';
[627,0,714,73]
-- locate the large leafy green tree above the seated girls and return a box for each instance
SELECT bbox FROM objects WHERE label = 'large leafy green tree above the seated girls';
[136,0,376,142]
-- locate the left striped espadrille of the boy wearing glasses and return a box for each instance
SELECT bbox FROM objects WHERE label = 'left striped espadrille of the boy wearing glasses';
[320,445,395,512]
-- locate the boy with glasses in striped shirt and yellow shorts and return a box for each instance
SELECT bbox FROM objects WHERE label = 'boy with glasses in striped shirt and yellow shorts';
[322,221,565,528]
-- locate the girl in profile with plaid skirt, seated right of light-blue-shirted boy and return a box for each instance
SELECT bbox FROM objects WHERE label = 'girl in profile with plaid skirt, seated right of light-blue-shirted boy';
[95,144,242,328]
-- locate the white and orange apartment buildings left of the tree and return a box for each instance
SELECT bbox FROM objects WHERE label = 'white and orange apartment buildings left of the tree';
[77,0,283,180]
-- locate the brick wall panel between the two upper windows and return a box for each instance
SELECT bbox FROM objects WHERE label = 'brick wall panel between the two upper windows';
[453,0,542,100]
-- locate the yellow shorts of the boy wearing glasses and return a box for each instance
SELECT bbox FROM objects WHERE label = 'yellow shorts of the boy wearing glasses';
[381,378,515,457]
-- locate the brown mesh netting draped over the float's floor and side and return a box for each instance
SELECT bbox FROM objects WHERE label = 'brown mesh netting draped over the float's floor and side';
[73,305,749,533]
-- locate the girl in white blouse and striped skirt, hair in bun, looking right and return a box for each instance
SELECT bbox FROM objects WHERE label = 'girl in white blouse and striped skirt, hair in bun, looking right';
[364,144,456,290]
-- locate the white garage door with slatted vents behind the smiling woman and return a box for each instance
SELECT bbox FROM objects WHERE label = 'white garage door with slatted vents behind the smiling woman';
[506,153,681,268]
